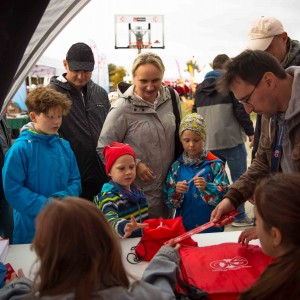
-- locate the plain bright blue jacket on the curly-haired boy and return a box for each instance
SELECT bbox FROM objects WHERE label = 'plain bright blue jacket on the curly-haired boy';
[2,123,81,244]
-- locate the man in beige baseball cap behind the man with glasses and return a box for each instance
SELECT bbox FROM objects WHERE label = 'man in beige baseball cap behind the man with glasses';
[248,16,300,160]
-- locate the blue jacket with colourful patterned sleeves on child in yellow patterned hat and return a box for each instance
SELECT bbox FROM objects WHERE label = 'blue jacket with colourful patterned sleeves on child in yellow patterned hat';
[164,152,229,233]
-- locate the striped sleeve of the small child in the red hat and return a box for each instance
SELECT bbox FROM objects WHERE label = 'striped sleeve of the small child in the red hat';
[94,192,129,238]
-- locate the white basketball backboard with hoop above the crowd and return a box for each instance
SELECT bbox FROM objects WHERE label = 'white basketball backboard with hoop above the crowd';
[115,15,165,50]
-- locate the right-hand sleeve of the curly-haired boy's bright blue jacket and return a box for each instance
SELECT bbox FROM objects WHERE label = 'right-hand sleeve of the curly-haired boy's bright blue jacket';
[52,146,81,198]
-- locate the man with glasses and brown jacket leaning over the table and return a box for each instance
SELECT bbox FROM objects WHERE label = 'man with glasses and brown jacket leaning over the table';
[211,50,300,232]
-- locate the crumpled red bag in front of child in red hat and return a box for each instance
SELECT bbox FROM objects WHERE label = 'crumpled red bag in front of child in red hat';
[135,217,198,261]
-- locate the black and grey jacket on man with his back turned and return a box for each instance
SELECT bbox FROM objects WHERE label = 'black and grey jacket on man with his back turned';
[193,70,254,151]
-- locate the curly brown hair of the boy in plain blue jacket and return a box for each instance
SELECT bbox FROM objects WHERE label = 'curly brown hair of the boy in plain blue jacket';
[25,85,72,115]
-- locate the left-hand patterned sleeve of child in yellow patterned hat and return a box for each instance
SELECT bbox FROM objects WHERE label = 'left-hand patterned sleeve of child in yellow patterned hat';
[163,161,184,208]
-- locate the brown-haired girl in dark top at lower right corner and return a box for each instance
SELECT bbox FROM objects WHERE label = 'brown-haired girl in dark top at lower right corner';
[239,173,300,300]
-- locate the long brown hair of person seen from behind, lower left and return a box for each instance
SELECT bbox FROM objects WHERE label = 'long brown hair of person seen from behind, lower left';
[33,197,129,299]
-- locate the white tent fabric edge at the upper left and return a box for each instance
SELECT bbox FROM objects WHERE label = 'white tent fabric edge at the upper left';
[1,0,90,117]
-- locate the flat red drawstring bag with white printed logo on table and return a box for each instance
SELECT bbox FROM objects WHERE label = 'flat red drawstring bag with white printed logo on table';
[176,243,274,300]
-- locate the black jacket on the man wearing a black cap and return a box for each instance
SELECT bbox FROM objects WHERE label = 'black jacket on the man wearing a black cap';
[49,74,110,188]
